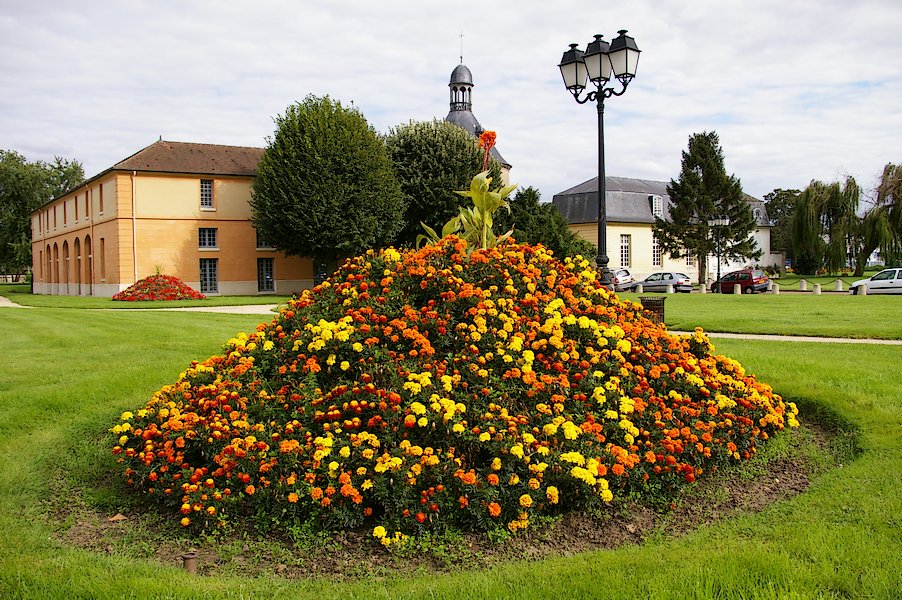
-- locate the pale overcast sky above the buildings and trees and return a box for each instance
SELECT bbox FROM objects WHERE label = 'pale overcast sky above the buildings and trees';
[0,0,902,201]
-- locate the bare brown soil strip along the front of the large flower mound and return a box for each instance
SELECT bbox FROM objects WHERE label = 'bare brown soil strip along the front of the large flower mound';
[51,420,844,580]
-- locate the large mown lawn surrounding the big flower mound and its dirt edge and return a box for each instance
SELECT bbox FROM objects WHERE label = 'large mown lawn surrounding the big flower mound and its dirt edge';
[0,308,902,599]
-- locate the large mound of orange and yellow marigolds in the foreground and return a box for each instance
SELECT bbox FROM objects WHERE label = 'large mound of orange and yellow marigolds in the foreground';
[113,237,798,546]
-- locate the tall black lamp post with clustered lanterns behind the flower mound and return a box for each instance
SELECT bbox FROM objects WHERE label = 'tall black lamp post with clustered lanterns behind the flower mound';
[558,29,640,287]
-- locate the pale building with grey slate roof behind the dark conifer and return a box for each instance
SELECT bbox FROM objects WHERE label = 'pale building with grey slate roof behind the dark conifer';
[552,177,784,280]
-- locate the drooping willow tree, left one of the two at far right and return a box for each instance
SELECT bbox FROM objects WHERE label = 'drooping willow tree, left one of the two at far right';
[792,177,862,275]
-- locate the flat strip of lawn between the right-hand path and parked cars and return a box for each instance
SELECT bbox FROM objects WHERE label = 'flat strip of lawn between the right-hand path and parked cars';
[620,294,902,340]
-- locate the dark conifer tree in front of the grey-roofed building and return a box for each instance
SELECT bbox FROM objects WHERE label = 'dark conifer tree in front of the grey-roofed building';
[654,131,761,284]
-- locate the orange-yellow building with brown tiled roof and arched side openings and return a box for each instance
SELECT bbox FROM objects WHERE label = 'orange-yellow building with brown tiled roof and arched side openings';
[31,140,313,297]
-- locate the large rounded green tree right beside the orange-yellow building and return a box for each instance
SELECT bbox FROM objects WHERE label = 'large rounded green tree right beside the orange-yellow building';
[251,96,404,272]
